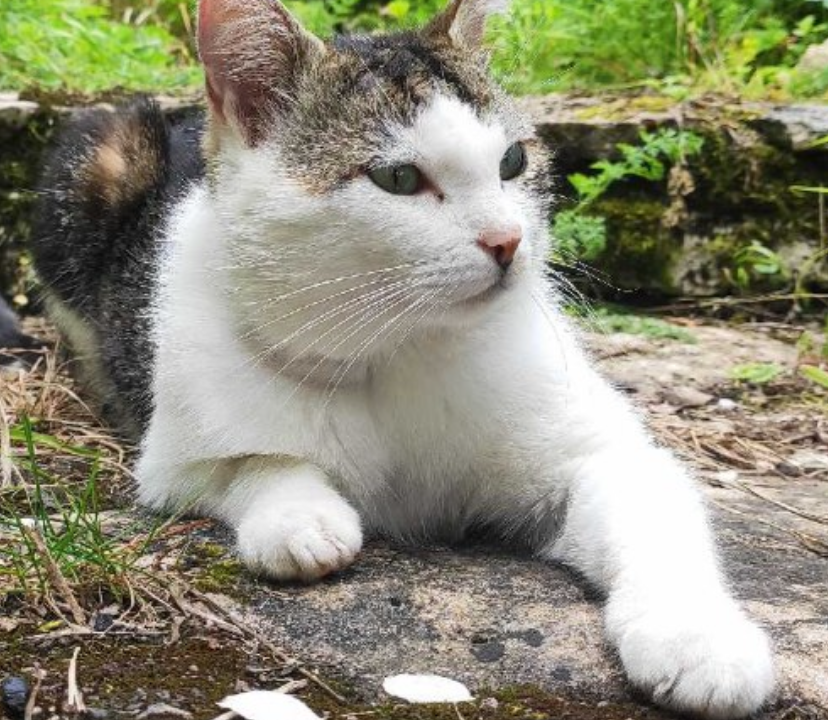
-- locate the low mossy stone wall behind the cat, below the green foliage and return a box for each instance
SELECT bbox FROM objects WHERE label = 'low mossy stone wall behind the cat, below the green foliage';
[0,90,828,300]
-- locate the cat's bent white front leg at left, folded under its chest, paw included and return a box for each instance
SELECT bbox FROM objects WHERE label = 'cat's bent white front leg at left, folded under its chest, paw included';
[137,453,362,581]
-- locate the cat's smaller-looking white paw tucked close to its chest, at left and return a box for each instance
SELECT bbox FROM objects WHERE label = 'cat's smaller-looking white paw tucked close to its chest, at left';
[238,498,362,581]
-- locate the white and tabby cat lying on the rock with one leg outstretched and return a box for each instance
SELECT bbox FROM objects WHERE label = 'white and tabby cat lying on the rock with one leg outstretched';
[29,0,774,718]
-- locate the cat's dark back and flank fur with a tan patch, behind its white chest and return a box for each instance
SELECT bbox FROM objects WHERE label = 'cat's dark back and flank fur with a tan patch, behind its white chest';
[32,98,204,432]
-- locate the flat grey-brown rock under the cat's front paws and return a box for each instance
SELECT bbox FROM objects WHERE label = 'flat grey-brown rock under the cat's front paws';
[236,488,828,718]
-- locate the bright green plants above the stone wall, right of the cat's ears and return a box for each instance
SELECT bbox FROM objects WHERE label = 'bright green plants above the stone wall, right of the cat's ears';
[493,0,828,96]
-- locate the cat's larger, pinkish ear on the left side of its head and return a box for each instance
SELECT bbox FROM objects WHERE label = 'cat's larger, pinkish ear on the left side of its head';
[198,0,325,146]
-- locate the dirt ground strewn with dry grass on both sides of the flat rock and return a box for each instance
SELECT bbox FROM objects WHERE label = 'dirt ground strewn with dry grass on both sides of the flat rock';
[0,318,828,720]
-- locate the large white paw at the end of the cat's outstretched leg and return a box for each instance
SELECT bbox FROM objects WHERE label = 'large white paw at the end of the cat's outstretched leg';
[607,601,774,718]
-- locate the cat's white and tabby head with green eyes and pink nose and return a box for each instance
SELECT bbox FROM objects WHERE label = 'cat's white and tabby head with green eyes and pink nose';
[198,0,547,366]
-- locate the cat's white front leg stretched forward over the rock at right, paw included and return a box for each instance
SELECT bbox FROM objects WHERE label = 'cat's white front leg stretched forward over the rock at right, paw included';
[540,408,774,718]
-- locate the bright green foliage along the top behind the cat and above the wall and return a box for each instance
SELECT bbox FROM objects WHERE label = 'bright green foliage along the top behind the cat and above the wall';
[0,0,828,100]
